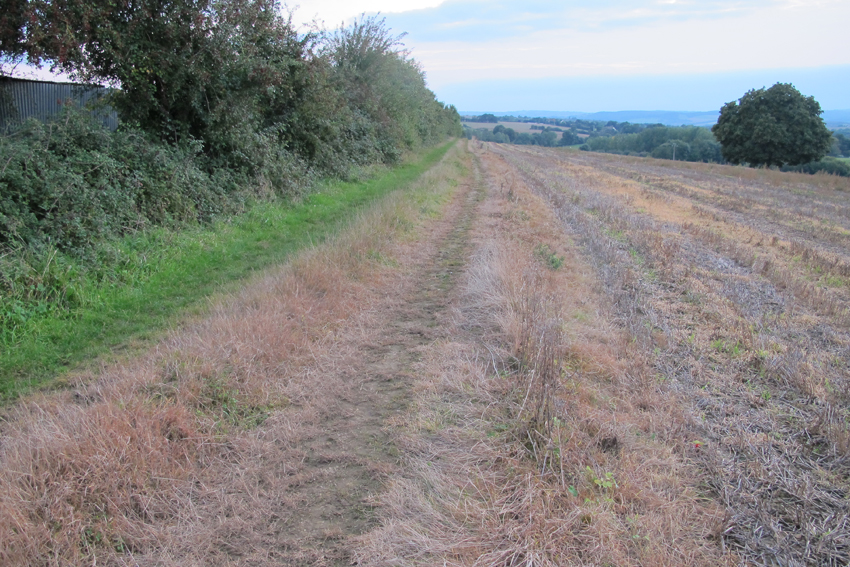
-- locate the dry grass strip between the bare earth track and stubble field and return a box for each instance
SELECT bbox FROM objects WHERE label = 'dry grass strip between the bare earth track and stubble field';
[359,145,733,566]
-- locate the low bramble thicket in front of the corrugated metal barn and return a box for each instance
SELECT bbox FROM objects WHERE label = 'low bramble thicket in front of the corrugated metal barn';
[0,107,274,256]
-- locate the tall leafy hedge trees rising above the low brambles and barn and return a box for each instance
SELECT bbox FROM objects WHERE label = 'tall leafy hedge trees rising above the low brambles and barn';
[0,0,460,178]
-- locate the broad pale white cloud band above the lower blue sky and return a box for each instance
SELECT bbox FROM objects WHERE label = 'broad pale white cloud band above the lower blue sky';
[403,0,850,88]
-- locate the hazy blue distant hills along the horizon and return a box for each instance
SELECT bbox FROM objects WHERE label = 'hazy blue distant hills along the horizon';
[460,109,850,128]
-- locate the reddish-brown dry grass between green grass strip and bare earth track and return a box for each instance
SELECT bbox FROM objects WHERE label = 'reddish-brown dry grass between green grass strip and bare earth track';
[0,143,470,566]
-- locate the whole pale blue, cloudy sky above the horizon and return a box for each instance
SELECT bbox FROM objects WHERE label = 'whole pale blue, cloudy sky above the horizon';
[289,0,850,112]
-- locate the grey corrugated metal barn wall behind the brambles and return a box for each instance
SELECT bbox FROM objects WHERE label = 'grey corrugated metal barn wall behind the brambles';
[0,77,118,131]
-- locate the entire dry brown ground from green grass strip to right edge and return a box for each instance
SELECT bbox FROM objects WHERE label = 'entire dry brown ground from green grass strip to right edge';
[0,141,850,567]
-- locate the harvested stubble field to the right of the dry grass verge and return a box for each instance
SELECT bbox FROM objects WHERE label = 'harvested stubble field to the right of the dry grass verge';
[484,144,850,565]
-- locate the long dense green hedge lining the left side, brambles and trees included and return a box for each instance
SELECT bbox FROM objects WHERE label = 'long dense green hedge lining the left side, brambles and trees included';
[0,12,460,254]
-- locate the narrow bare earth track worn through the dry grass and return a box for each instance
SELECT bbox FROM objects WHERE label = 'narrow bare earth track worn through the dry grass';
[252,158,481,565]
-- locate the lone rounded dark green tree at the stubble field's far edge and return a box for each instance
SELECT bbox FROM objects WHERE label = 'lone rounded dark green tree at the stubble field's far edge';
[711,83,832,167]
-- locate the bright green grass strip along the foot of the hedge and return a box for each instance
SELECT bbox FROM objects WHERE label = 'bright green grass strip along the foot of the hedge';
[0,142,453,401]
